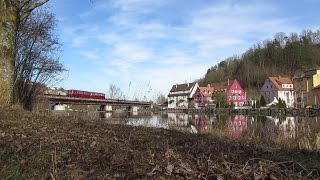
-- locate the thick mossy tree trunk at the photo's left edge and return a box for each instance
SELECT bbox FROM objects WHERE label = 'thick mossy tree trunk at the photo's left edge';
[0,0,49,105]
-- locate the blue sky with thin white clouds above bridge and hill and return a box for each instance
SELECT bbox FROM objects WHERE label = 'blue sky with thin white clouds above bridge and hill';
[48,0,320,99]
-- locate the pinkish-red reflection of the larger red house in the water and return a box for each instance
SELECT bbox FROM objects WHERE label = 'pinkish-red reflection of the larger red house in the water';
[228,115,248,138]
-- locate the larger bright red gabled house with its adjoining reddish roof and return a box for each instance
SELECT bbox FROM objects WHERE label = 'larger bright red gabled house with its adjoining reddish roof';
[211,79,247,107]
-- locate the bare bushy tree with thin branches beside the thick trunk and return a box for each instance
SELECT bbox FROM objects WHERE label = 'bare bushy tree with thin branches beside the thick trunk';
[14,8,64,110]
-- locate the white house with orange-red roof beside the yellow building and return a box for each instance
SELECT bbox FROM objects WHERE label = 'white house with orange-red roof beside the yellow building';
[260,76,295,107]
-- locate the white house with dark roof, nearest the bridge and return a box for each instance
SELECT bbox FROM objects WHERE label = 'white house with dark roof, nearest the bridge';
[168,82,199,109]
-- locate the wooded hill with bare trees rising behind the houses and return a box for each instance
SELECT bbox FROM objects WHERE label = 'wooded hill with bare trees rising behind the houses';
[199,30,320,93]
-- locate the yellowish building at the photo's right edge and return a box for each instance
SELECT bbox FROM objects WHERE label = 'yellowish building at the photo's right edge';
[293,69,320,107]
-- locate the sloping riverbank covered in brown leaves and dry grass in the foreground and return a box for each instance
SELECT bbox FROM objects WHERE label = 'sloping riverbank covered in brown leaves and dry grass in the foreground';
[0,108,320,179]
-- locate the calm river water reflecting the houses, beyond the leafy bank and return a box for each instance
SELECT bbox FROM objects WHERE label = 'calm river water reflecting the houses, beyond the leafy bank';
[52,112,320,150]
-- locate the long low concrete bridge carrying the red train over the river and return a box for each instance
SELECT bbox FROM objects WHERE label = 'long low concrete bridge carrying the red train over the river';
[44,95,151,112]
